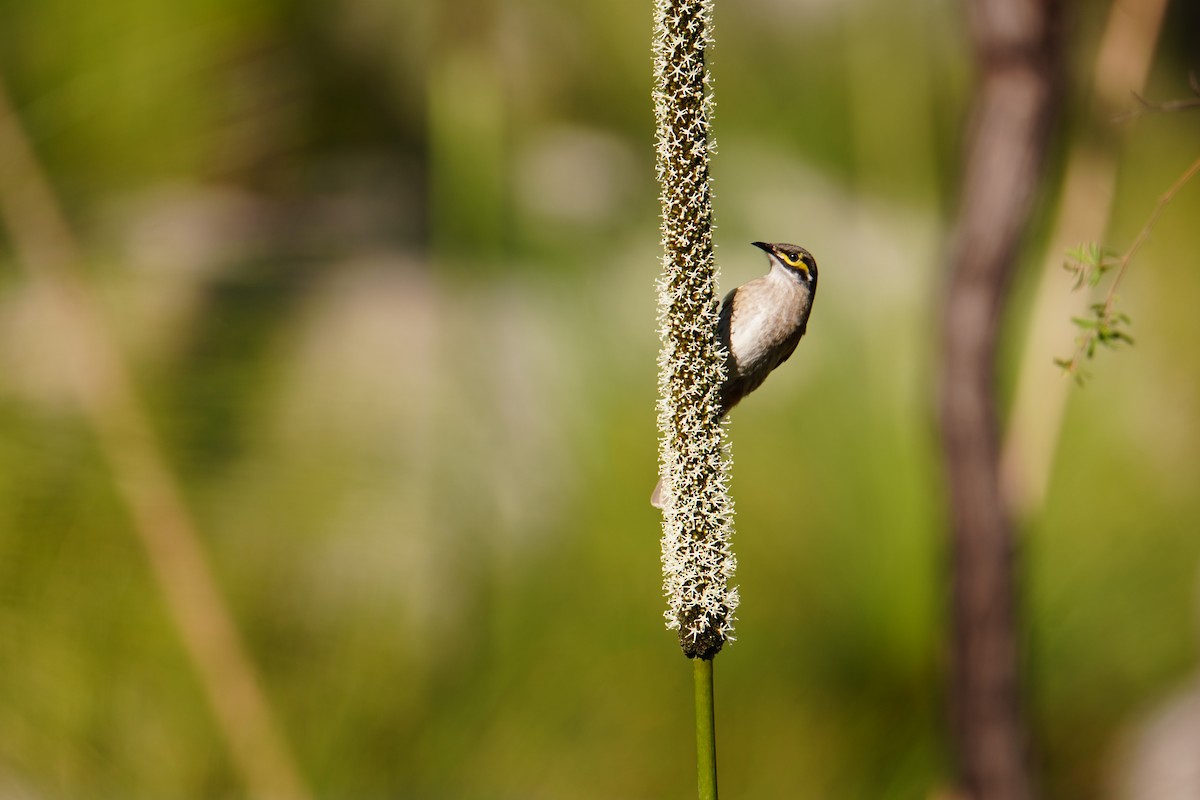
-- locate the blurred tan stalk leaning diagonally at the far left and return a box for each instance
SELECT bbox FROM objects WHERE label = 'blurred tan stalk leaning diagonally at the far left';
[0,71,308,800]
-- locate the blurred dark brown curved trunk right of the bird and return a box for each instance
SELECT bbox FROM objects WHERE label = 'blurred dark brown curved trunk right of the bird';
[940,0,1060,800]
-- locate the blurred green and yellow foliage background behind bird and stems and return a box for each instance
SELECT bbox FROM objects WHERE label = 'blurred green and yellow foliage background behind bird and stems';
[0,0,1200,800]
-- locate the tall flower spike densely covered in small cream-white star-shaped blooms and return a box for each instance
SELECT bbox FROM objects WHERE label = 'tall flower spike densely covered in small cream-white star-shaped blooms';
[654,0,738,657]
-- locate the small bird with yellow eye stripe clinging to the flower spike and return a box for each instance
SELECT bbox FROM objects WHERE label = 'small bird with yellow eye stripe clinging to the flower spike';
[650,241,817,509]
